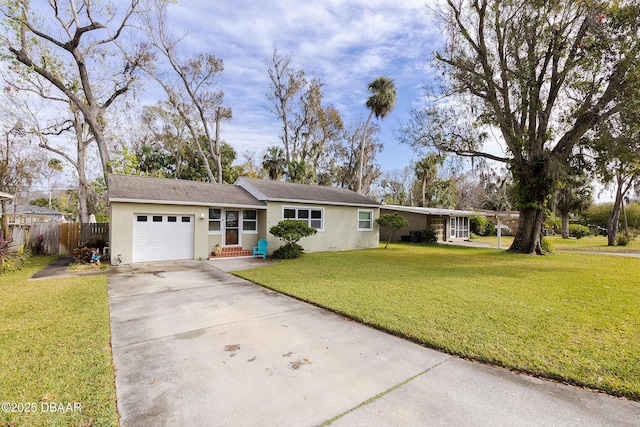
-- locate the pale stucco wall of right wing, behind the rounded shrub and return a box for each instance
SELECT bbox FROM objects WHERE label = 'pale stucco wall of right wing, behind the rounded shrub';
[265,202,380,253]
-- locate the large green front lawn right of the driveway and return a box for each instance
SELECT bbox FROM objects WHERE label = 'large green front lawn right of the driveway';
[236,243,640,400]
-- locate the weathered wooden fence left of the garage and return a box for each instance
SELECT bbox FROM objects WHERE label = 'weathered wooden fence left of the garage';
[9,222,109,256]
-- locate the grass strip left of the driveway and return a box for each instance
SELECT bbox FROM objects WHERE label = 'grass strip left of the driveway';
[0,257,118,427]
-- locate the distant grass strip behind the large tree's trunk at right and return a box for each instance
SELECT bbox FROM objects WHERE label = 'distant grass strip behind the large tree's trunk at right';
[472,235,640,253]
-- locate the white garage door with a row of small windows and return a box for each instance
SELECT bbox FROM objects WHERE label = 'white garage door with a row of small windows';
[133,214,194,262]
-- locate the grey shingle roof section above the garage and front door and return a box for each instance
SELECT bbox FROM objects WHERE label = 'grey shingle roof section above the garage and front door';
[107,174,266,209]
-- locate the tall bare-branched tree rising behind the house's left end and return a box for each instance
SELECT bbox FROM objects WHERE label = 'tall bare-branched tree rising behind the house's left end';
[0,0,152,181]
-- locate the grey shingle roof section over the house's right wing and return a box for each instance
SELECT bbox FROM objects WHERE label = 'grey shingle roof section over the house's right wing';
[235,178,380,207]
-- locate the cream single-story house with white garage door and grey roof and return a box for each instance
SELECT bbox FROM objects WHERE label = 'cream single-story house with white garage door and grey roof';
[107,174,380,264]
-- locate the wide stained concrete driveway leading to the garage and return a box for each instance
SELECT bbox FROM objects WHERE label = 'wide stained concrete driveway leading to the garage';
[108,261,640,427]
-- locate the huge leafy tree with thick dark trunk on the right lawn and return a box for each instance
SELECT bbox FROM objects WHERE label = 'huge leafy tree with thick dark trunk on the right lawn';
[404,0,640,254]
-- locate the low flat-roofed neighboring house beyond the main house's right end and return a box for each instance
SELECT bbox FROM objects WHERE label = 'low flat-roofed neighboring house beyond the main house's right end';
[380,205,478,242]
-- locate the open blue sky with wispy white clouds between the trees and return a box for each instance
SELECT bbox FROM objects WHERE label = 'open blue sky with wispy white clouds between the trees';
[154,0,440,170]
